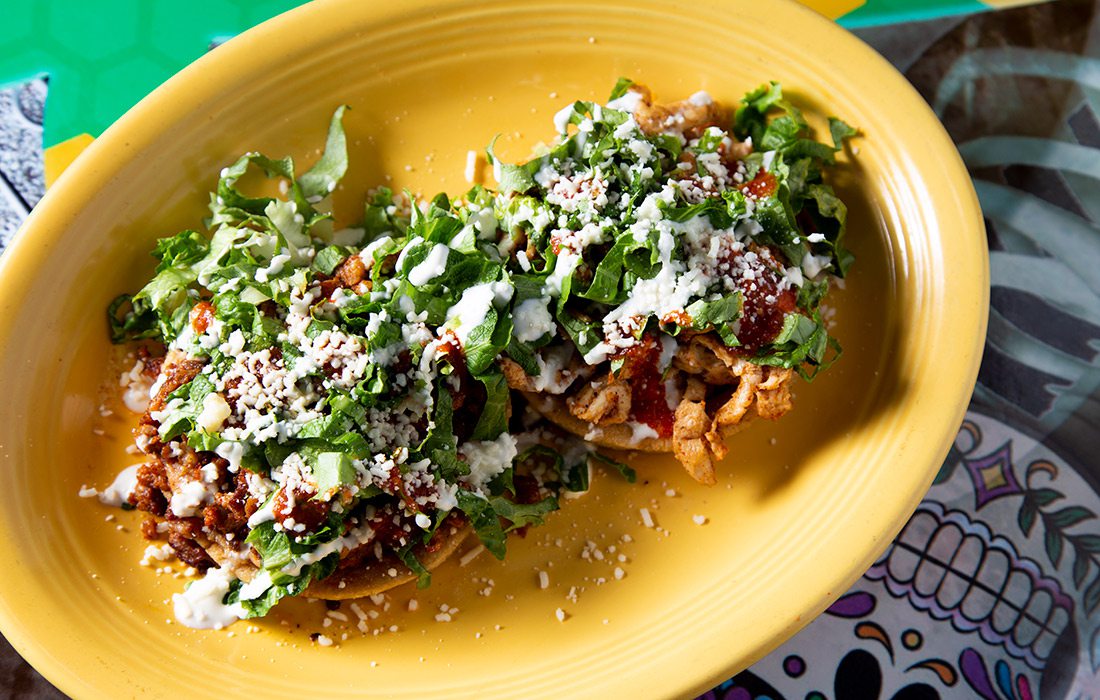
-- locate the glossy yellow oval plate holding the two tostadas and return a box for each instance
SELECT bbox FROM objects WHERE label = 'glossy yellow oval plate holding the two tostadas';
[0,0,988,698]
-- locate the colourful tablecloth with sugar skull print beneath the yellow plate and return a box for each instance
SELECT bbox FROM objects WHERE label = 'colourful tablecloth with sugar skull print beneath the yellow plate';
[0,0,1100,700]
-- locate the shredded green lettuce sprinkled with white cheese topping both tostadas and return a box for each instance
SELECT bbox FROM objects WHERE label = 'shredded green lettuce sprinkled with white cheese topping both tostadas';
[108,78,857,616]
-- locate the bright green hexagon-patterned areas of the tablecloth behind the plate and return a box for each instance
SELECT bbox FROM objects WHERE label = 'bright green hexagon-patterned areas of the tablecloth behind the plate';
[0,0,1012,147]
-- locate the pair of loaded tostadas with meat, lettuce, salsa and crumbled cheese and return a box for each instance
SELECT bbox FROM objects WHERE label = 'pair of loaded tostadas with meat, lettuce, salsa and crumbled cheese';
[88,80,855,628]
